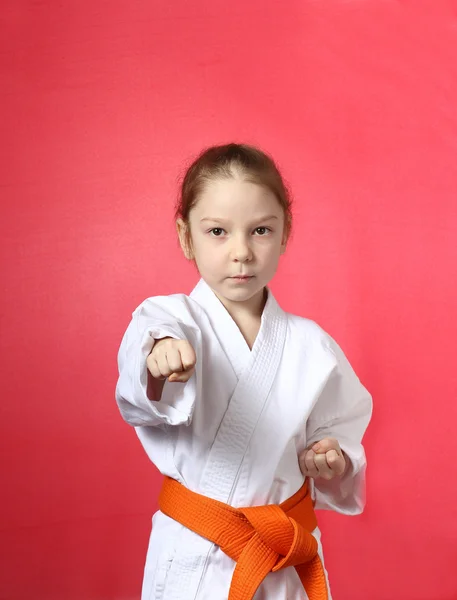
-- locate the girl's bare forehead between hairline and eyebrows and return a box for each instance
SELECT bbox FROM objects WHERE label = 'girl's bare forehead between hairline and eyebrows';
[194,179,283,217]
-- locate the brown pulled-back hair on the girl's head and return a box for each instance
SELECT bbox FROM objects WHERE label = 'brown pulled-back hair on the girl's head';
[175,143,292,234]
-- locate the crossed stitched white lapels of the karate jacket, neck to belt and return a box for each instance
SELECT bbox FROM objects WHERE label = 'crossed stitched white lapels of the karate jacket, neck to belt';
[192,281,287,502]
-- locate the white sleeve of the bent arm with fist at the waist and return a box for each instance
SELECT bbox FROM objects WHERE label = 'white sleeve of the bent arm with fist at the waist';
[306,337,372,515]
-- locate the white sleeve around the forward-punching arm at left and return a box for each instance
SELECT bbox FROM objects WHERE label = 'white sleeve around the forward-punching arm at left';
[116,295,201,426]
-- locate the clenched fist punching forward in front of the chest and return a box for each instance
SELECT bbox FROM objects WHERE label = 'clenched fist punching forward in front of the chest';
[146,338,197,383]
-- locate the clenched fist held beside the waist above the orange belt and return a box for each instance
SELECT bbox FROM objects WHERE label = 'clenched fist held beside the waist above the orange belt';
[298,438,347,481]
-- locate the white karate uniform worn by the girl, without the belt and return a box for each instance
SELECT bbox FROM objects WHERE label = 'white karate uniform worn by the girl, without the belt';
[116,280,372,600]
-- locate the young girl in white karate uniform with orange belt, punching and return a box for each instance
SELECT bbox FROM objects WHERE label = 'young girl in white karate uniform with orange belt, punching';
[116,144,371,600]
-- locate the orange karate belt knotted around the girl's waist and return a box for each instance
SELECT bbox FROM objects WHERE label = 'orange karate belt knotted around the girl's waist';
[159,477,328,600]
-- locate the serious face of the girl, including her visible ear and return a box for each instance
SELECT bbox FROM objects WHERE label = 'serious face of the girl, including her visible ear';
[178,179,287,310]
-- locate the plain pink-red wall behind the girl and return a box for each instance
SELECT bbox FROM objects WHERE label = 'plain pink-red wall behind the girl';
[0,0,457,600]
